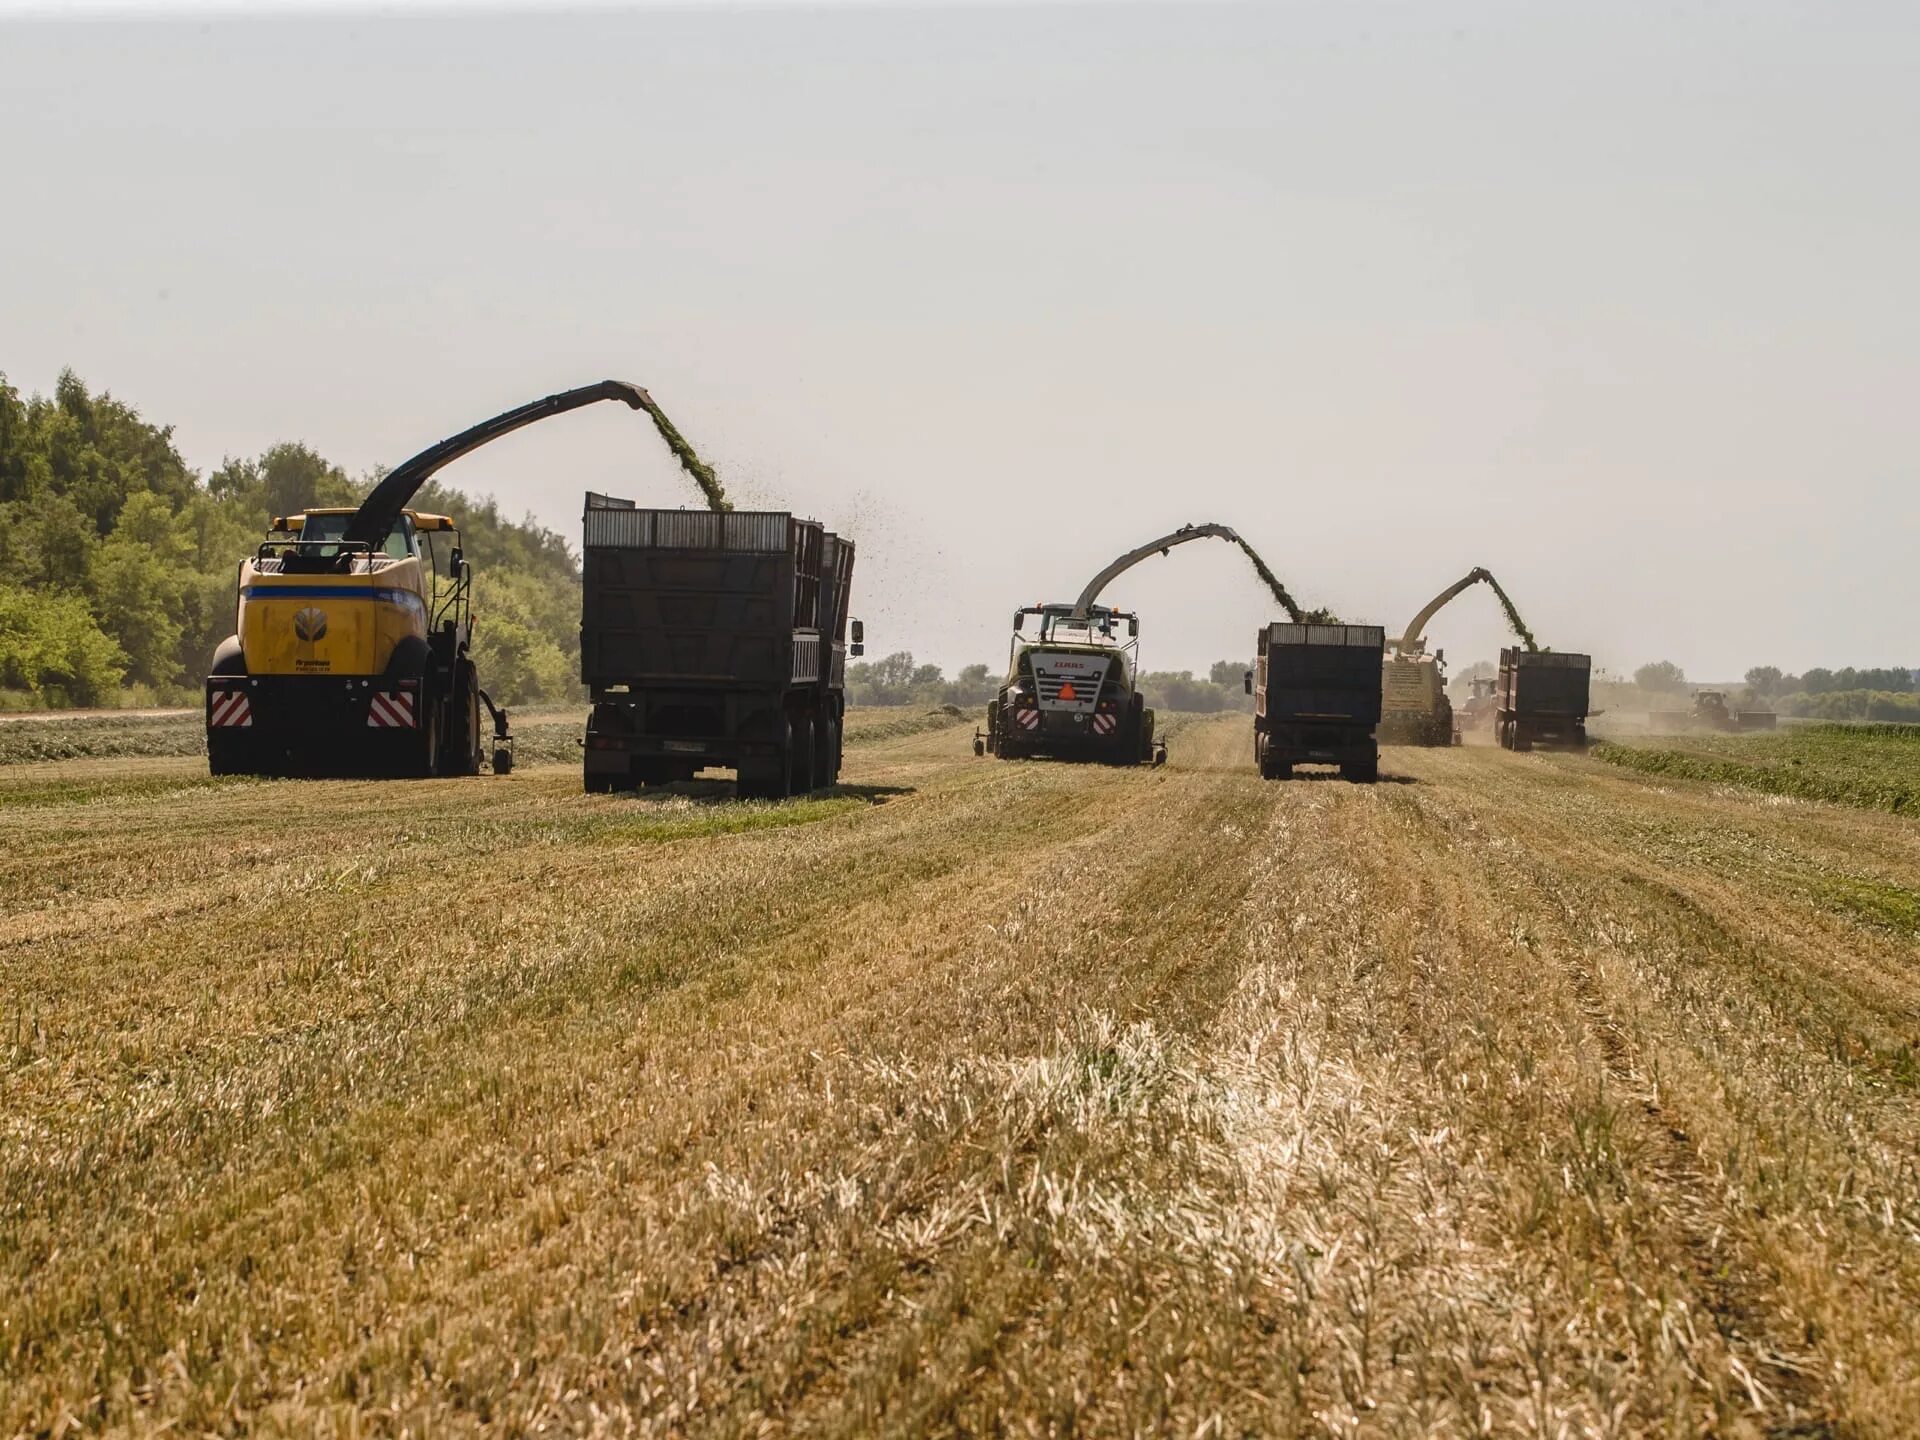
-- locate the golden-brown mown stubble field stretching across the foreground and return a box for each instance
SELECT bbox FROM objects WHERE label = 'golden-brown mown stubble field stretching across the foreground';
[0,716,1920,1436]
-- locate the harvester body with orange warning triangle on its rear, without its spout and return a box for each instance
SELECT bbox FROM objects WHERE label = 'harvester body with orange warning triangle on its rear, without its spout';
[973,603,1165,764]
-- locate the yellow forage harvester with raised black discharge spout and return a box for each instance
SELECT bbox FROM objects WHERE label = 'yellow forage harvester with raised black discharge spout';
[204,380,645,776]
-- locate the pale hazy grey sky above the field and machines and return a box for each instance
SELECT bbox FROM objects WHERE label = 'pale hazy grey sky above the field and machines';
[0,0,1920,678]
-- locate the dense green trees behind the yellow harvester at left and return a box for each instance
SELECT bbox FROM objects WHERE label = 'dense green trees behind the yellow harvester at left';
[0,371,580,708]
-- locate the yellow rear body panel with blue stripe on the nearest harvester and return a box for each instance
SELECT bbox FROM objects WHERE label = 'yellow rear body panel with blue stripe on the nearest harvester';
[240,557,426,676]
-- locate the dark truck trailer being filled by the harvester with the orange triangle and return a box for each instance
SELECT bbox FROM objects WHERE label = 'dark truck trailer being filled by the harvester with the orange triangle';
[1246,620,1386,781]
